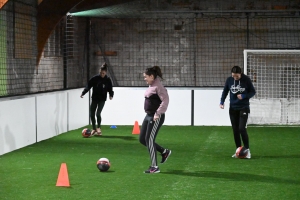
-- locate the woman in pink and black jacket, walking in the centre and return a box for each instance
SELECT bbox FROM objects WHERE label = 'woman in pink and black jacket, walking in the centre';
[139,66,171,173]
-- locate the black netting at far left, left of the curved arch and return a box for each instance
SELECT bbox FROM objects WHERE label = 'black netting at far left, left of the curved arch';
[0,1,37,96]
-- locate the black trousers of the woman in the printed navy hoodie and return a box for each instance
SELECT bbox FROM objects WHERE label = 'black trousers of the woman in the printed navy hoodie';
[229,108,250,149]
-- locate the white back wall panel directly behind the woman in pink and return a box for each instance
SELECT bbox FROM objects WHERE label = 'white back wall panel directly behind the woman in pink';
[101,87,191,125]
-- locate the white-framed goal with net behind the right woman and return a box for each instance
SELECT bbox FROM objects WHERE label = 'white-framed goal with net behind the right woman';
[244,50,300,125]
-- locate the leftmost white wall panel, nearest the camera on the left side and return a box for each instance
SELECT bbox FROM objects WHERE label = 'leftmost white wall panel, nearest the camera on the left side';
[0,97,36,155]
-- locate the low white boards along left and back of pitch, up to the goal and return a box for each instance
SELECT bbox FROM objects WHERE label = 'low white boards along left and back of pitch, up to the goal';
[0,87,230,155]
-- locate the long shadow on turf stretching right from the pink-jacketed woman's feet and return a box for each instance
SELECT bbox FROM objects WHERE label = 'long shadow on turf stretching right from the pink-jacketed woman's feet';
[161,170,300,185]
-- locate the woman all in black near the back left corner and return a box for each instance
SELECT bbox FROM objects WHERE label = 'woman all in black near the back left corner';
[80,63,114,135]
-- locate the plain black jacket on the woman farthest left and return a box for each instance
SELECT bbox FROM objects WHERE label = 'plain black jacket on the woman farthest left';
[82,74,114,101]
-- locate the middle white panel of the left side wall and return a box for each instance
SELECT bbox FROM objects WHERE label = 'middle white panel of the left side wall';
[37,91,67,142]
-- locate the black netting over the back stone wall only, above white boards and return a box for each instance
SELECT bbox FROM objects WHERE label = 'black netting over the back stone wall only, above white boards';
[91,13,300,87]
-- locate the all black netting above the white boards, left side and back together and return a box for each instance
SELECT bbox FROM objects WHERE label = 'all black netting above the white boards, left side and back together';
[0,0,300,97]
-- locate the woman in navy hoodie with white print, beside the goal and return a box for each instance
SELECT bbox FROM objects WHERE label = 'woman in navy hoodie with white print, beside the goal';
[219,66,256,159]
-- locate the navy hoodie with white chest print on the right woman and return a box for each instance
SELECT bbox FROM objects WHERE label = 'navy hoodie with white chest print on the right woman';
[220,74,256,110]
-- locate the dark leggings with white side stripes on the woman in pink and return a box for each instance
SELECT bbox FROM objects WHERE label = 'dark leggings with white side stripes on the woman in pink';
[140,114,165,166]
